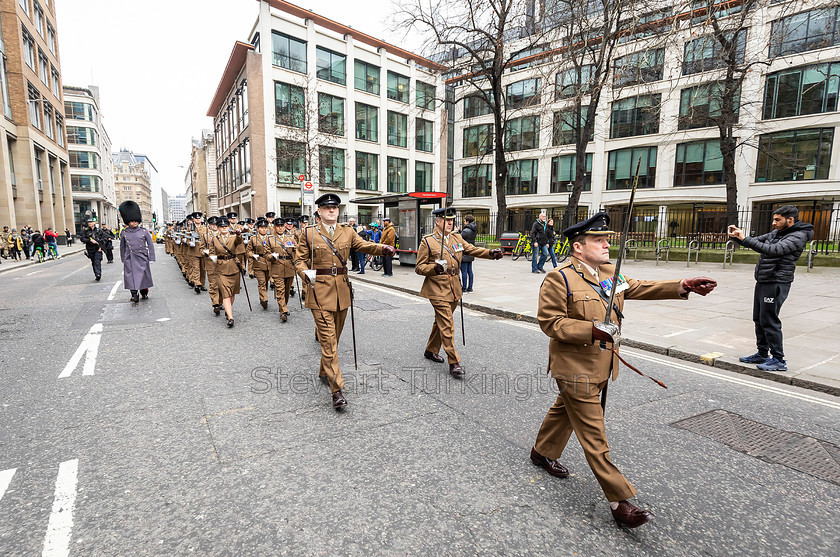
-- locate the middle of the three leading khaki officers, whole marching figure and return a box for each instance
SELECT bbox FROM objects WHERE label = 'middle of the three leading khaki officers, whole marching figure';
[414,207,502,377]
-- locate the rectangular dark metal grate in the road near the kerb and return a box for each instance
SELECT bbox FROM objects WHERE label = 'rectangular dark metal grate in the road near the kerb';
[671,410,840,485]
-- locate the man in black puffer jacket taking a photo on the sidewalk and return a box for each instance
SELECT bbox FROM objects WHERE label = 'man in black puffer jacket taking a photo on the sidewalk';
[729,205,814,371]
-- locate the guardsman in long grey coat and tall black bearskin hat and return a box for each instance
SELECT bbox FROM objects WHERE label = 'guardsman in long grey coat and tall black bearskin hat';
[119,200,155,304]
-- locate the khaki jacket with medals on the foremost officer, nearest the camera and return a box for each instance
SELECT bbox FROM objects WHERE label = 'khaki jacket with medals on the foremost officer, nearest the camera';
[537,257,687,384]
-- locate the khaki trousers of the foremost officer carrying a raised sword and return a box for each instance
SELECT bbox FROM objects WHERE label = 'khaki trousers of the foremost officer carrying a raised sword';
[534,379,636,502]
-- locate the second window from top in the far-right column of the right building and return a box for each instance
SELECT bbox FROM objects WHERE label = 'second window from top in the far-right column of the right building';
[763,63,840,119]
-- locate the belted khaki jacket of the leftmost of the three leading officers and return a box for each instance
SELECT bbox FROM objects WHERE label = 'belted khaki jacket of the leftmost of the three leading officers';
[295,224,382,311]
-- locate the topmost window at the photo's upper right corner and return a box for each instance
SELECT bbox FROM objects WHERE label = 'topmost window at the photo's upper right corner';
[770,6,840,58]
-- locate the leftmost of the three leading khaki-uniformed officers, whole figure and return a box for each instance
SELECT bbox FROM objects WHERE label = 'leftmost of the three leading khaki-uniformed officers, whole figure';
[295,193,394,408]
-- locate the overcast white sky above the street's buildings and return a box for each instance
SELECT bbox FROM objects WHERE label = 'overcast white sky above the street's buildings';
[55,0,416,199]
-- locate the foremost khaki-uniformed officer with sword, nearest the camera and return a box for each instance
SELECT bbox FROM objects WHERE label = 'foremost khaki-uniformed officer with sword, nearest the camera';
[531,212,716,528]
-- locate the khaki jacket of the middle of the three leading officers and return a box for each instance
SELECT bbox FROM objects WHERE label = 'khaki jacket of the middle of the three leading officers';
[414,232,490,302]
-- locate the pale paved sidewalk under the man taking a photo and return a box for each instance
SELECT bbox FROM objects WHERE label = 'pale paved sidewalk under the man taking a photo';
[351,256,840,396]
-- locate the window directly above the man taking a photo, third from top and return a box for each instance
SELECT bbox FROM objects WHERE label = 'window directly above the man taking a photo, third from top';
[755,128,834,182]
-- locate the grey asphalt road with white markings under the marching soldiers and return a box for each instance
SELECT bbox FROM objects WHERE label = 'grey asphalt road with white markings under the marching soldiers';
[0,253,840,555]
